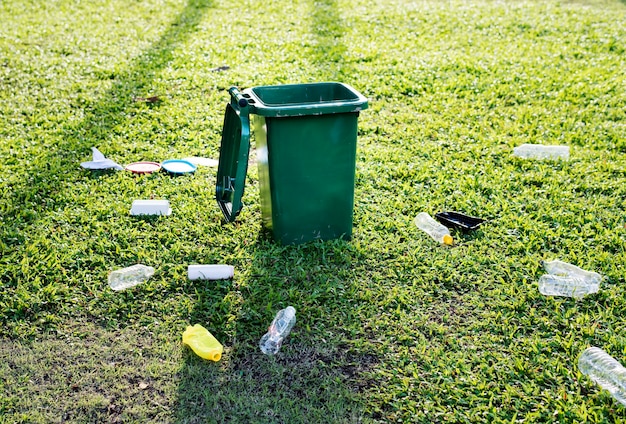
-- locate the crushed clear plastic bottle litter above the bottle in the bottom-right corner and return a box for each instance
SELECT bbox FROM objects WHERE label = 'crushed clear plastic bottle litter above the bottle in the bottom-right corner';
[539,260,602,299]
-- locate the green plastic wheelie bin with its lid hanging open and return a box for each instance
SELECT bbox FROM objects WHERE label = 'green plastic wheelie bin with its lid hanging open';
[216,82,367,244]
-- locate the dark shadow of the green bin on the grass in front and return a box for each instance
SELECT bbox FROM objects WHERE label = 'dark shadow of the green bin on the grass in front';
[176,240,378,423]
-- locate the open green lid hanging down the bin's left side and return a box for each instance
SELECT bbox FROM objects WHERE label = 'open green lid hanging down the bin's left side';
[215,87,250,222]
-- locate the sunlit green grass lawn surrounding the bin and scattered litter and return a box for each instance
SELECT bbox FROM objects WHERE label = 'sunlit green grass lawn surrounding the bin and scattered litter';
[0,0,626,423]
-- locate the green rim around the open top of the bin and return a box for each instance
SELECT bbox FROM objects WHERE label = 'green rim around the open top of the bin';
[243,82,367,117]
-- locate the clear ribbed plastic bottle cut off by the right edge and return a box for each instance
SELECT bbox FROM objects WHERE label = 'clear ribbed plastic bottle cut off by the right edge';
[578,346,626,406]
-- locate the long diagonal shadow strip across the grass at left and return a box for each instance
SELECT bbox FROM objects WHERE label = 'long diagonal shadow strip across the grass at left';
[0,0,213,332]
